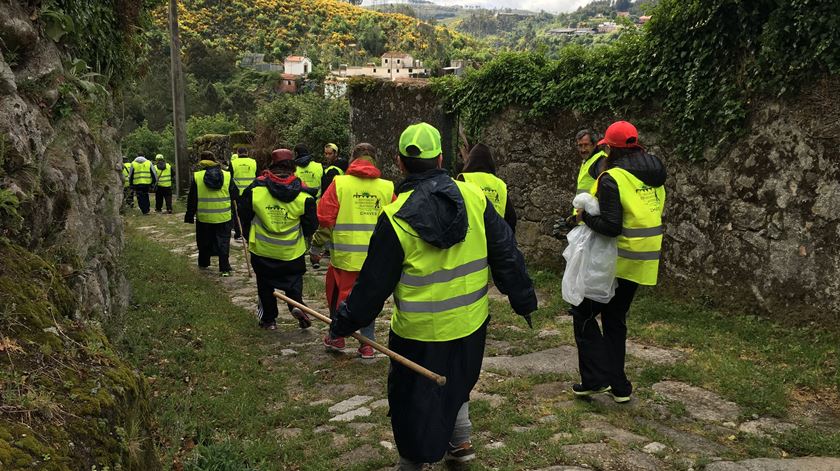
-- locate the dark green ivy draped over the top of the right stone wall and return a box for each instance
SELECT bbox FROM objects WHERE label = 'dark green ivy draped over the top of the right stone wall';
[435,0,840,160]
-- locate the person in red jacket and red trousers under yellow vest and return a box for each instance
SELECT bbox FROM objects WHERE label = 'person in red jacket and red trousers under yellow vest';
[318,142,395,359]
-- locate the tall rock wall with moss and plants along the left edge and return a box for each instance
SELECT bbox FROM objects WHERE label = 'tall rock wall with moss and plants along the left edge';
[0,0,159,470]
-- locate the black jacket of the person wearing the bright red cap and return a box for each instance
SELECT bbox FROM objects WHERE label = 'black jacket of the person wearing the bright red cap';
[583,149,666,237]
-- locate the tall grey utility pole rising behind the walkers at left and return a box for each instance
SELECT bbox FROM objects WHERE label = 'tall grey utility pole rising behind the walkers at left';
[169,0,190,196]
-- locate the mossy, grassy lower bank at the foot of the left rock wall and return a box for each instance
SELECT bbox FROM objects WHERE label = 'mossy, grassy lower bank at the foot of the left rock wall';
[0,241,160,470]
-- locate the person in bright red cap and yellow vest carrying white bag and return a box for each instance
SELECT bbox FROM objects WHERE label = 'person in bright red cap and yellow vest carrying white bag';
[571,121,665,403]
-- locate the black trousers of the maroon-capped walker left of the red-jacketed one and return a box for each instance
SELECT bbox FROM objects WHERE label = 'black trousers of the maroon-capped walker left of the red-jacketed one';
[251,253,306,324]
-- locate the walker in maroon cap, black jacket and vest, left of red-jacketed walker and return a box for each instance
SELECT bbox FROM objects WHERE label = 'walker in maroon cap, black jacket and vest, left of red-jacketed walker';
[239,149,318,330]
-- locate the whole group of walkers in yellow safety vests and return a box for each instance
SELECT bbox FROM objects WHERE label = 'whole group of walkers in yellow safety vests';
[124,122,665,470]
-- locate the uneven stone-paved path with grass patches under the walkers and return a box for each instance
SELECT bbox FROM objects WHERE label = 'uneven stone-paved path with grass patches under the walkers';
[130,215,840,471]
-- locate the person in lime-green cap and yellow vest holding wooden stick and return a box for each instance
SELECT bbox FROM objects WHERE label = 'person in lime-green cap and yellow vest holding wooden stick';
[330,123,537,470]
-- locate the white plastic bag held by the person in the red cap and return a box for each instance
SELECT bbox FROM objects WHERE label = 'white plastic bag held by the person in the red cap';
[562,193,618,306]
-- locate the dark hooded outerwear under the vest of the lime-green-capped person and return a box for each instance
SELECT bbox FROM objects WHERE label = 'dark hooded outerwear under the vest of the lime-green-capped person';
[330,170,537,463]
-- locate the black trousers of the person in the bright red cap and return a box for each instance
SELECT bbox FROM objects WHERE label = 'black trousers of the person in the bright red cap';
[571,278,639,396]
